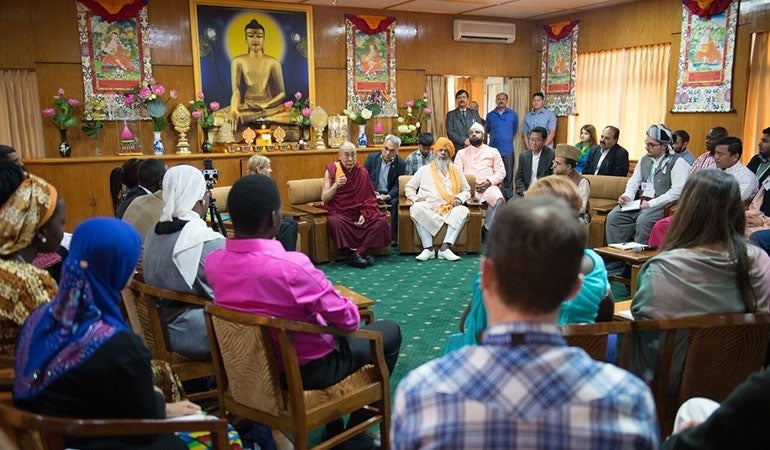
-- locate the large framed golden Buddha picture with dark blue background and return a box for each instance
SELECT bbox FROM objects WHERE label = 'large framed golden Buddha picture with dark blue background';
[190,0,315,130]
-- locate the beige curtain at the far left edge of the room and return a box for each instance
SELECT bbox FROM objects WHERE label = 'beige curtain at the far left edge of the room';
[0,70,45,159]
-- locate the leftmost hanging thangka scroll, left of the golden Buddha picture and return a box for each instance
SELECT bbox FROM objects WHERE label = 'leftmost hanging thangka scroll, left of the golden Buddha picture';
[77,2,152,120]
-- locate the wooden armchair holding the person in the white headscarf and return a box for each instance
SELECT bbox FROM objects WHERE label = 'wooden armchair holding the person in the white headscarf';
[123,279,217,401]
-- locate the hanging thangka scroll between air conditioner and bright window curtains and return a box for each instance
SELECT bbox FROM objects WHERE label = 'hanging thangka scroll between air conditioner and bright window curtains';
[540,20,580,116]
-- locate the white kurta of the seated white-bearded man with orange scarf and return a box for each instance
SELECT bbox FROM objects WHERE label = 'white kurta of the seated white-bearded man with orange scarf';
[404,164,471,236]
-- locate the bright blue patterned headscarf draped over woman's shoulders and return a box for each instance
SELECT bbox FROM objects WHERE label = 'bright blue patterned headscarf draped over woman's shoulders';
[13,217,142,399]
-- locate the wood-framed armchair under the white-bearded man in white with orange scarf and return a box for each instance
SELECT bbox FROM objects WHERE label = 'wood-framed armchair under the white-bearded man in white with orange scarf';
[398,175,484,253]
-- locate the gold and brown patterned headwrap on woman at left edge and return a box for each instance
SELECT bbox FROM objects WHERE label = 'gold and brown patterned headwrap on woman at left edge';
[0,175,58,256]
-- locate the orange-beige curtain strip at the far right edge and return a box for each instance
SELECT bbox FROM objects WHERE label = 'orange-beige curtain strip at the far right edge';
[742,32,770,163]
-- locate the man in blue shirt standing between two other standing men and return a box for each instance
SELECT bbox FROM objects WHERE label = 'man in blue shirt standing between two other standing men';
[482,92,519,199]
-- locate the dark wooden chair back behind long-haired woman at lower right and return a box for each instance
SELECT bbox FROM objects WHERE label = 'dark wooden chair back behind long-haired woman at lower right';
[631,314,770,436]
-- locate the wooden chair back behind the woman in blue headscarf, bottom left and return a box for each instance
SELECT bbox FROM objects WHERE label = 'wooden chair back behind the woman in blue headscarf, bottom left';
[0,396,230,450]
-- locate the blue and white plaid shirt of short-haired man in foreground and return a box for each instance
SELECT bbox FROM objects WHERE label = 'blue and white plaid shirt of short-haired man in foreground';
[391,322,660,450]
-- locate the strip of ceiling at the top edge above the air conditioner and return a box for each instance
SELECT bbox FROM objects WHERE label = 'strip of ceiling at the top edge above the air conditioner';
[273,0,637,20]
